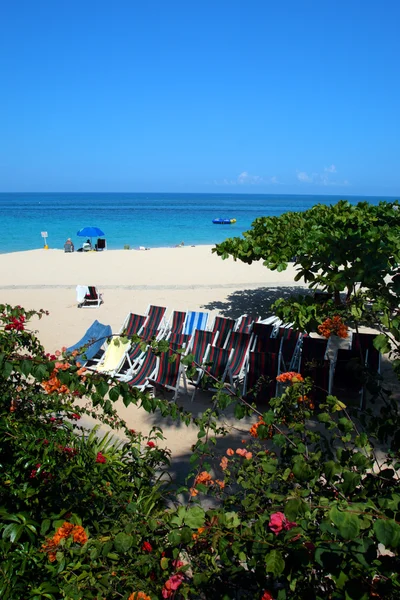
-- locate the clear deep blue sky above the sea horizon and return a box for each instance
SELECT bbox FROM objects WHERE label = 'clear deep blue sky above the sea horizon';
[0,0,400,196]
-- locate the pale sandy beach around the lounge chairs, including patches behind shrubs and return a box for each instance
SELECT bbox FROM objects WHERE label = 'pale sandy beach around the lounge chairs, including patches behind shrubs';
[0,246,310,478]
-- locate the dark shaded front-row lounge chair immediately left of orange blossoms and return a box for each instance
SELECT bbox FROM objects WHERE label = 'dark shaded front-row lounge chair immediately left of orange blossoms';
[243,352,280,404]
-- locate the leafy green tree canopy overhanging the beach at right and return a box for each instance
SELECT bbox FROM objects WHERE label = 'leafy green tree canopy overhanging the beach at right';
[213,200,400,303]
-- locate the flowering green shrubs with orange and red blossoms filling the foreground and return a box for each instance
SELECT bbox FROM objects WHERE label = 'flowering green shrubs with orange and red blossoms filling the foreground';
[0,306,400,600]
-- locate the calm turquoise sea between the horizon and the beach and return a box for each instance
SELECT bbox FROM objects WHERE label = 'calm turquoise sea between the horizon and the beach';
[0,193,394,253]
